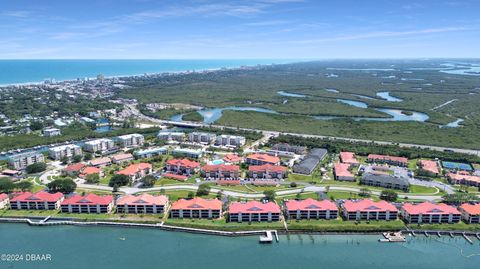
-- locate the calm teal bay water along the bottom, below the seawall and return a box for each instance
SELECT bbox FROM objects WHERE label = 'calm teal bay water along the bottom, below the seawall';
[0,224,480,269]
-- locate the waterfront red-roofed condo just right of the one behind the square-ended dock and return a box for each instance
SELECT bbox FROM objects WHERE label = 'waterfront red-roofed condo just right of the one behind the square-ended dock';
[285,198,338,220]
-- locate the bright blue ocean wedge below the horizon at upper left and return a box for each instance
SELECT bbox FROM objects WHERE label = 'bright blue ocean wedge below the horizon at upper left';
[0,59,293,85]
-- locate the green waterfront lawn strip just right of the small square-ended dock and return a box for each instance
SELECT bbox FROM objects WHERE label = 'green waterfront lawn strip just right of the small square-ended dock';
[287,218,405,232]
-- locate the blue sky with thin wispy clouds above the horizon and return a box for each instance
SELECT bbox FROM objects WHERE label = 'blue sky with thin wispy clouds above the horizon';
[0,0,480,59]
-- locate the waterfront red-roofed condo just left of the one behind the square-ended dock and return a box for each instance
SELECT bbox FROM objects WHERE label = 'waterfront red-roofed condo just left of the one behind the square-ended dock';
[170,197,222,219]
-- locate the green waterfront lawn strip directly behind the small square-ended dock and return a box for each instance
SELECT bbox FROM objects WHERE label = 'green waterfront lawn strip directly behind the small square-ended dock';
[165,216,283,231]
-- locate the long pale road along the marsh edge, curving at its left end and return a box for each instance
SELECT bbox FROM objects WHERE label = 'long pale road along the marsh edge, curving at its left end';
[125,104,480,156]
